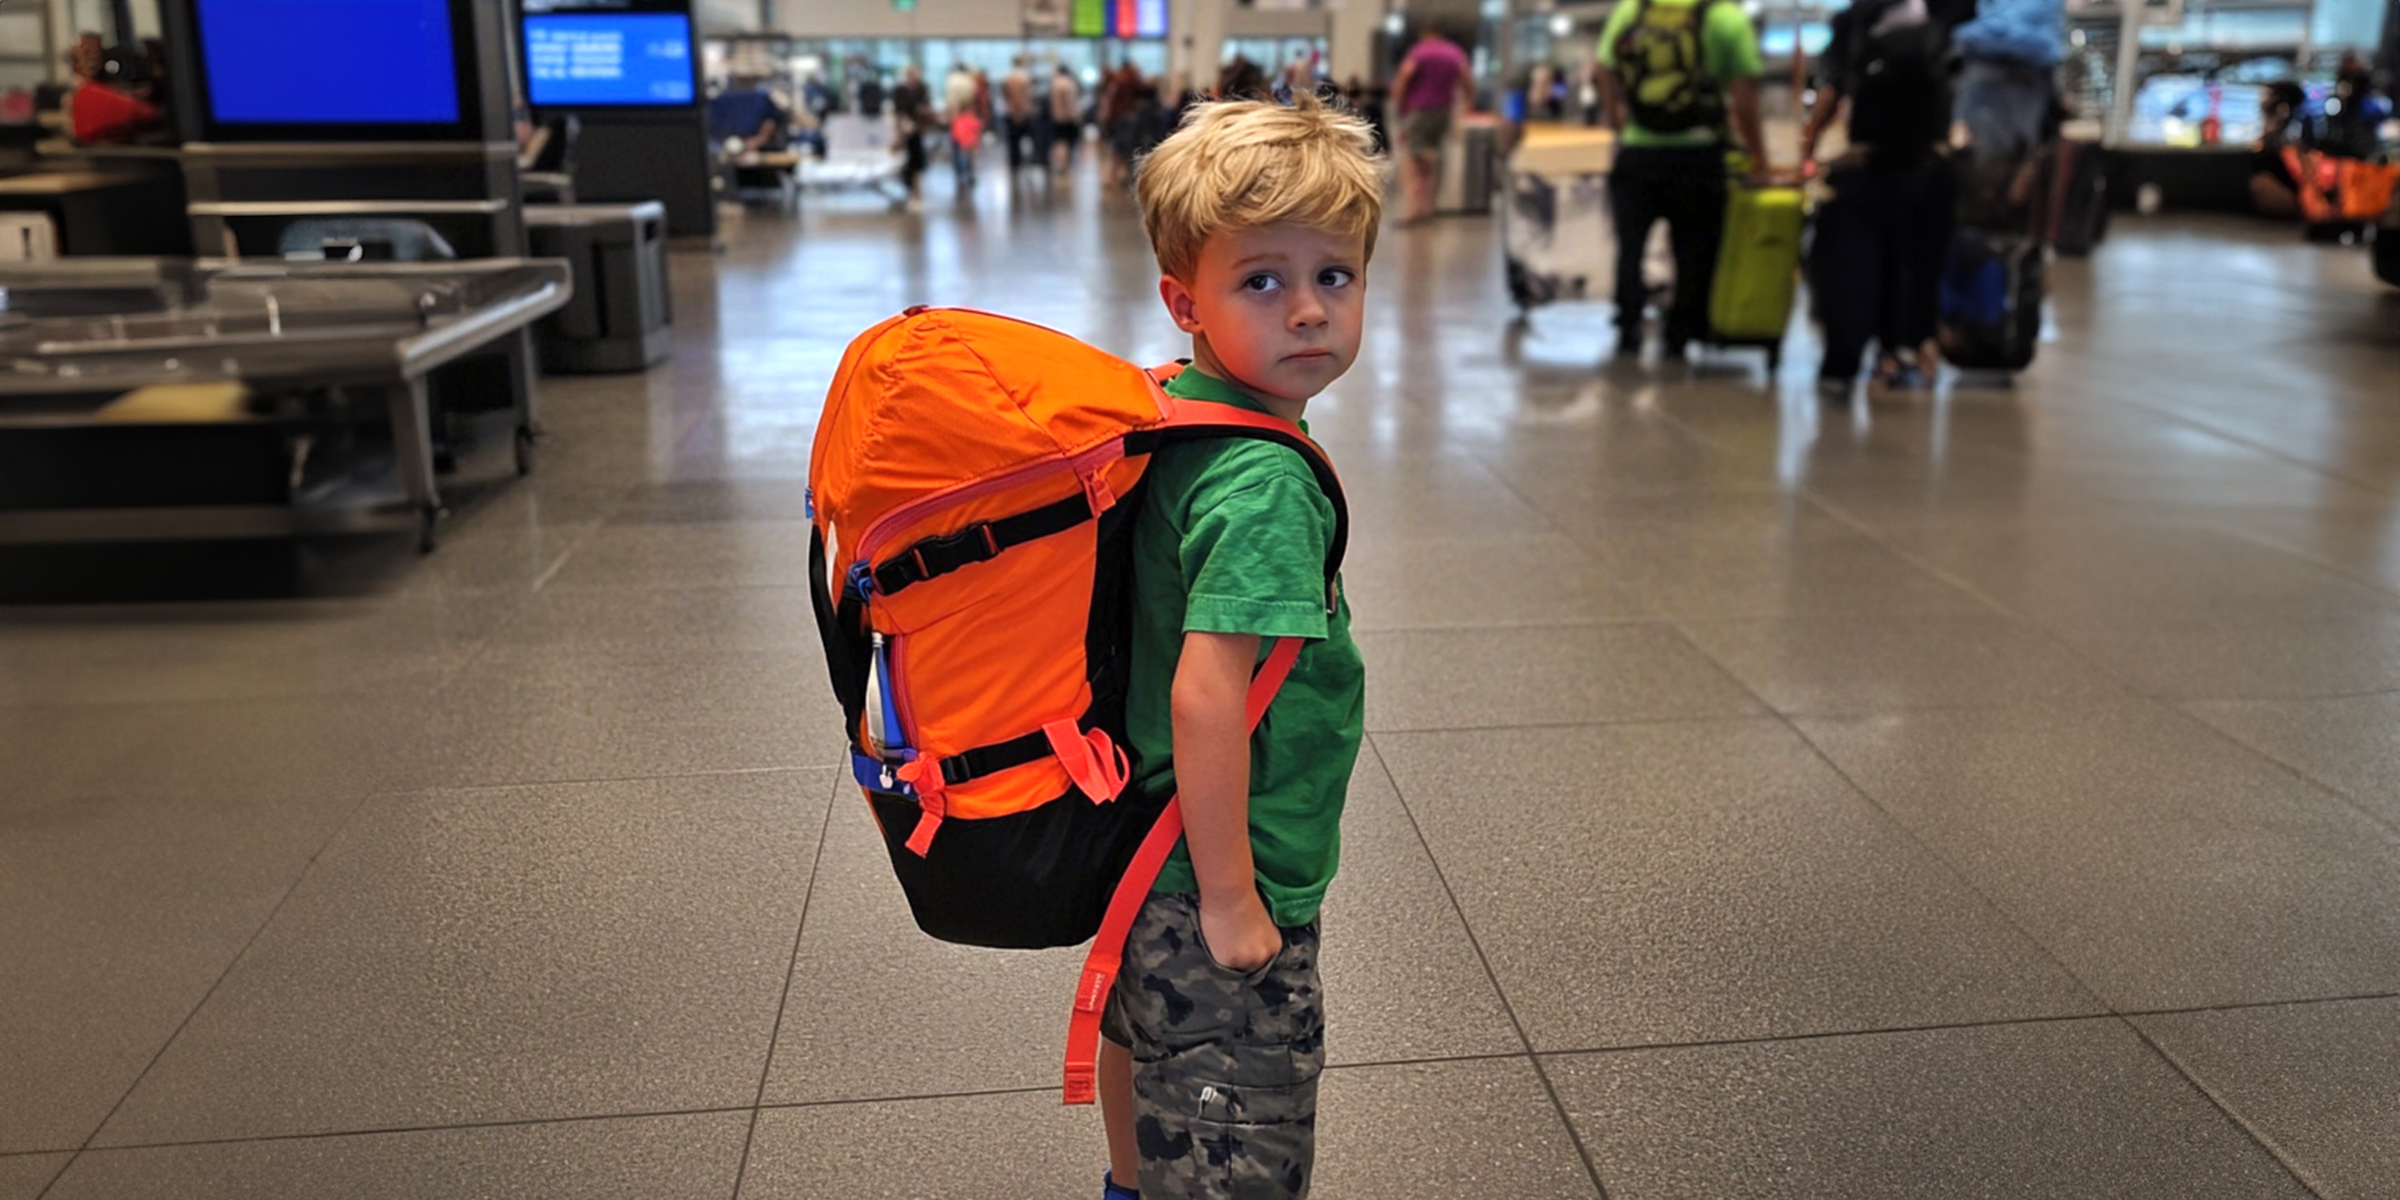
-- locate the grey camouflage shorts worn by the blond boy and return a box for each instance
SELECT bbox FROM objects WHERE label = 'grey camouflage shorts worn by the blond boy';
[1102,893,1325,1200]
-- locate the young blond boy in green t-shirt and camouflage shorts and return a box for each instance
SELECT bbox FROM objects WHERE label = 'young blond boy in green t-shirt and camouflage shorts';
[1099,94,1382,1200]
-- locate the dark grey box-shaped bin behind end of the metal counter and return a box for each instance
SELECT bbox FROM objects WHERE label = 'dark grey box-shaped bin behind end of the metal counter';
[526,199,674,374]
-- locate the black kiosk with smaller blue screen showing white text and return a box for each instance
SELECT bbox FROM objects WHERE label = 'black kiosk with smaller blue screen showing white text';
[516,0,718,240]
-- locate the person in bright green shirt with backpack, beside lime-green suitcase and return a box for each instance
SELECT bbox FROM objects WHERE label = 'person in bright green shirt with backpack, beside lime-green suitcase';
[1598,0,1766,358]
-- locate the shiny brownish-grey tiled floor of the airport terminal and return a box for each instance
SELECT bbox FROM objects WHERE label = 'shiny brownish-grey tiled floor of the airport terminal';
[0,170,2400,1200]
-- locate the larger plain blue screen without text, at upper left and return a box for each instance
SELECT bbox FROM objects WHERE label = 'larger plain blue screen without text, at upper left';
[194,0,473,127]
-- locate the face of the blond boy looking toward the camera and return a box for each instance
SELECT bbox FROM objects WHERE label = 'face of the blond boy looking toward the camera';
[1159,223,1366,415]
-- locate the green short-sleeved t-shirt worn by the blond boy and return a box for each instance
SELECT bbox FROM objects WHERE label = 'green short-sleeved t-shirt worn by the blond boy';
[1126,367,1366,926]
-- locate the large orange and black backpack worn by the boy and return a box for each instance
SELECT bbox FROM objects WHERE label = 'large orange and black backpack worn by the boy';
[809,307,1346,1104]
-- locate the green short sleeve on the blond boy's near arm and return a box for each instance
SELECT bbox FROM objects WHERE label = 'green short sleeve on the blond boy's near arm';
[1183,444,1334,638]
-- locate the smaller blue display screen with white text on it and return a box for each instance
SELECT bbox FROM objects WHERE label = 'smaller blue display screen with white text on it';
[523,12,698,108]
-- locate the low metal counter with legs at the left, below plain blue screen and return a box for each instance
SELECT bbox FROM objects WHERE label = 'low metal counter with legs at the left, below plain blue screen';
[0,259,574,550]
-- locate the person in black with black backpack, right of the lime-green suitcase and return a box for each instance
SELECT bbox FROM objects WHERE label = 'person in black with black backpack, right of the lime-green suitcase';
[1800,0,1958,398]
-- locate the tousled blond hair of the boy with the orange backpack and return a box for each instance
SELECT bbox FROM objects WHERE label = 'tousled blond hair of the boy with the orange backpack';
[1133,91,1382,278]
